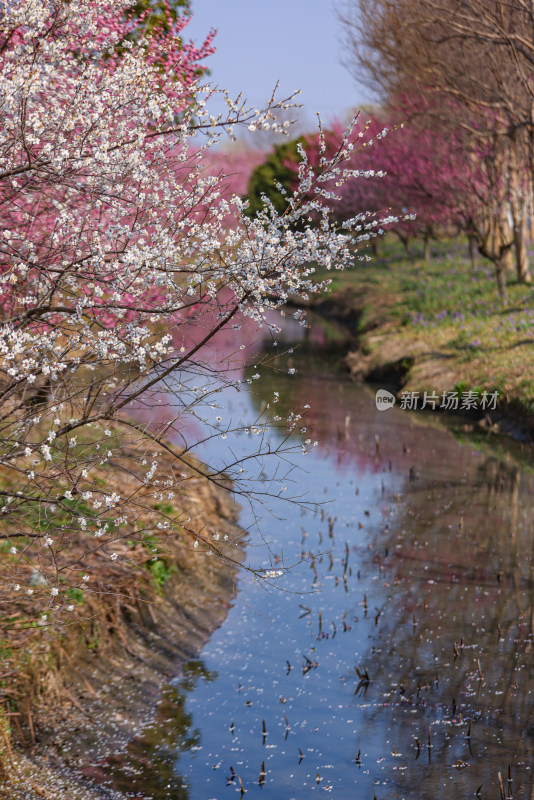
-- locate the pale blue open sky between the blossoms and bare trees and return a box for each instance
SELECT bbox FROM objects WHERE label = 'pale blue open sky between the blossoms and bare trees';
[188,0,371,124]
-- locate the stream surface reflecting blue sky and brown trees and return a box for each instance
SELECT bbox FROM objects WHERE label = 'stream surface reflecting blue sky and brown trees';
[102,332,534,800]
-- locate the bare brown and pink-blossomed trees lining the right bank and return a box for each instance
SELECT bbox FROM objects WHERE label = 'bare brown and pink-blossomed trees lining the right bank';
[243,0,534,297]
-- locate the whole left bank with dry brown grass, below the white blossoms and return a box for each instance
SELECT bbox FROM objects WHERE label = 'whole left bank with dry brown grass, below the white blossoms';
[0,451,243,800]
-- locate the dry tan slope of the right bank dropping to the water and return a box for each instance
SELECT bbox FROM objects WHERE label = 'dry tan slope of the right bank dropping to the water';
[289,281,534,441]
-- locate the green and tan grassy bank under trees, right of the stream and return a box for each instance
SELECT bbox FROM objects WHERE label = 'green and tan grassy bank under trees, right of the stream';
[308,237,534,433]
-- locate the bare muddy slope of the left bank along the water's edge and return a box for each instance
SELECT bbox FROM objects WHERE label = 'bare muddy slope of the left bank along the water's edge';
[0,481,243,800]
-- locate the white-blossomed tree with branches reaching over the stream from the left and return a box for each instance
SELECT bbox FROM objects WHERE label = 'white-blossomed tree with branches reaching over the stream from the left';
[0,0,394,598]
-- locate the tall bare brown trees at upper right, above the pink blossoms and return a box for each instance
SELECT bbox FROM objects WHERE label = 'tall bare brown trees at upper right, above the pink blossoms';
[343,0,534,295]
